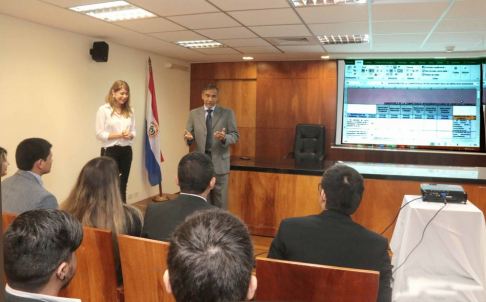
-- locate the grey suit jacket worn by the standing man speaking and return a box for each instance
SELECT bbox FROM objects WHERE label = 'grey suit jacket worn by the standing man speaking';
[186,106,240,175]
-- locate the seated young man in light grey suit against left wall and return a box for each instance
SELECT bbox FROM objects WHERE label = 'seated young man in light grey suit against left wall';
[2,138,58,214]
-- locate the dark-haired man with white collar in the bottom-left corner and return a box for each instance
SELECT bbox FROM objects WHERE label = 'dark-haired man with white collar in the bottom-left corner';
[3,209,83,302]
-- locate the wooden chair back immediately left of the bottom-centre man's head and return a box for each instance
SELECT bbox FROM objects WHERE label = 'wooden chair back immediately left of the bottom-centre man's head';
[118,235,175,302]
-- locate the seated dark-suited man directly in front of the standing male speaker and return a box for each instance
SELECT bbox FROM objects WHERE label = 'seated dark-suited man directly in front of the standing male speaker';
[142,152,217,241]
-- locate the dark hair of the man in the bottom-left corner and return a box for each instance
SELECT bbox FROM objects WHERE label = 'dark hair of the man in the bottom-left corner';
[3,209,83,293]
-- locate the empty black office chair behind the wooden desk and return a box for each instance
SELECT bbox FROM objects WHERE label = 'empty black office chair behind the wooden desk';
[284,124,326,161]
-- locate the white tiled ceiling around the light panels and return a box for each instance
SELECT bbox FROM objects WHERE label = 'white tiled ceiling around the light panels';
[0,0,486,62]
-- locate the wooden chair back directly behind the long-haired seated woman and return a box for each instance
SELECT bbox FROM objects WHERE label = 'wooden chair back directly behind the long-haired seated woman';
[59,227,123,302]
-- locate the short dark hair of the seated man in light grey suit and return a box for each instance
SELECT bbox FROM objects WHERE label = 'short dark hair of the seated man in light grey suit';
[15,138,52,171]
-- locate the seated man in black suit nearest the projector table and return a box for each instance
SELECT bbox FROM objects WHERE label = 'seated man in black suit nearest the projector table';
[268,165,392,302]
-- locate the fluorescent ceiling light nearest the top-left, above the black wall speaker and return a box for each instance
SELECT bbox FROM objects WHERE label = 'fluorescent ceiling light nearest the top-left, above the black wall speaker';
[69,1,156,22]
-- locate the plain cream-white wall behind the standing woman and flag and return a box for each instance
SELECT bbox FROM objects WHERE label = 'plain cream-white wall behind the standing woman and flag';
[0,14,190,203]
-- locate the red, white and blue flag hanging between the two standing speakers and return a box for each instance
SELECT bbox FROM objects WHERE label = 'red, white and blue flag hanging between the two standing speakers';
[145,58,164,186]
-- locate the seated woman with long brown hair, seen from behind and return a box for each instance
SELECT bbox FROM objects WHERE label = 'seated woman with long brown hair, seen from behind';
[60,156,143,285]
